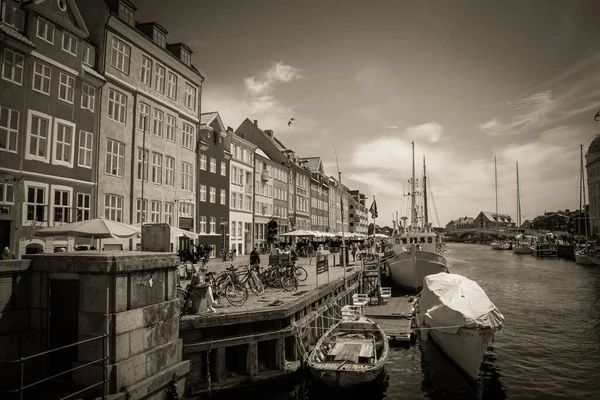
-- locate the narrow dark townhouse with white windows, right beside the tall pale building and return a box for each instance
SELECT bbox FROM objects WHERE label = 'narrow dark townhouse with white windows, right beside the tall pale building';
[196,112,232,257]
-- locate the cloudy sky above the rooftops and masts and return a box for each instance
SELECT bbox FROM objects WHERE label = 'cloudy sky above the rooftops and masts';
[134,0,600,226]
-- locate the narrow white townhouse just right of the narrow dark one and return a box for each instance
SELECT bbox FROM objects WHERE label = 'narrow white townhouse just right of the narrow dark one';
[229,128,256,255]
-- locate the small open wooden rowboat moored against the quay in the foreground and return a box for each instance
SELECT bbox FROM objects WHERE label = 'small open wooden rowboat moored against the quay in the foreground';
[307,306,389,388]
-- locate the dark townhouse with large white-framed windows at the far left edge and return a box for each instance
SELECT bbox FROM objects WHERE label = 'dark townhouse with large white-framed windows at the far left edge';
[0,0,104,257]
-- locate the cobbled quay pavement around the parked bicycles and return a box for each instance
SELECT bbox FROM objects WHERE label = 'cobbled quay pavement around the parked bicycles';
[181,255,360,319]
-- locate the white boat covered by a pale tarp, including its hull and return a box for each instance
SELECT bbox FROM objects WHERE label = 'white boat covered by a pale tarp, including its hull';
[416,273,504,380]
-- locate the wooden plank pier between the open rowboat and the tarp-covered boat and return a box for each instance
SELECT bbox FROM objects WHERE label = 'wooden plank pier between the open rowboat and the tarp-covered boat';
[364,296,415,342]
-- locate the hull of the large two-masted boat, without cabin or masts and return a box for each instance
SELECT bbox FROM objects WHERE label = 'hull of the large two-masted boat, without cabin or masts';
[388,248,448,291]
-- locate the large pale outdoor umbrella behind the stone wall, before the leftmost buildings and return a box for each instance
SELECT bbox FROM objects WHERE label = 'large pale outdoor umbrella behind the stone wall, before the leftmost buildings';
[35,218,140,239]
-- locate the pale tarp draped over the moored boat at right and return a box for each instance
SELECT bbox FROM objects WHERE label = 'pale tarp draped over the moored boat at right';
[419,272,504,333]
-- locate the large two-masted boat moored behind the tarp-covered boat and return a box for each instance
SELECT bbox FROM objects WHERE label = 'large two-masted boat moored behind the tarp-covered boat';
[387,142,448,291]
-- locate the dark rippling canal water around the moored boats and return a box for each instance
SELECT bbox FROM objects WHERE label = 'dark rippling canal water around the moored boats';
[212,243,600,400]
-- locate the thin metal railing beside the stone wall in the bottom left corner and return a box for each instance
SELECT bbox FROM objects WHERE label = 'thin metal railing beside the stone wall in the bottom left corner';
[0,334,108,400]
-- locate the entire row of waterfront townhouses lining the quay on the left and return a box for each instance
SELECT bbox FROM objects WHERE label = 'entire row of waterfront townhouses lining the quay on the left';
[0,0,367,256]
